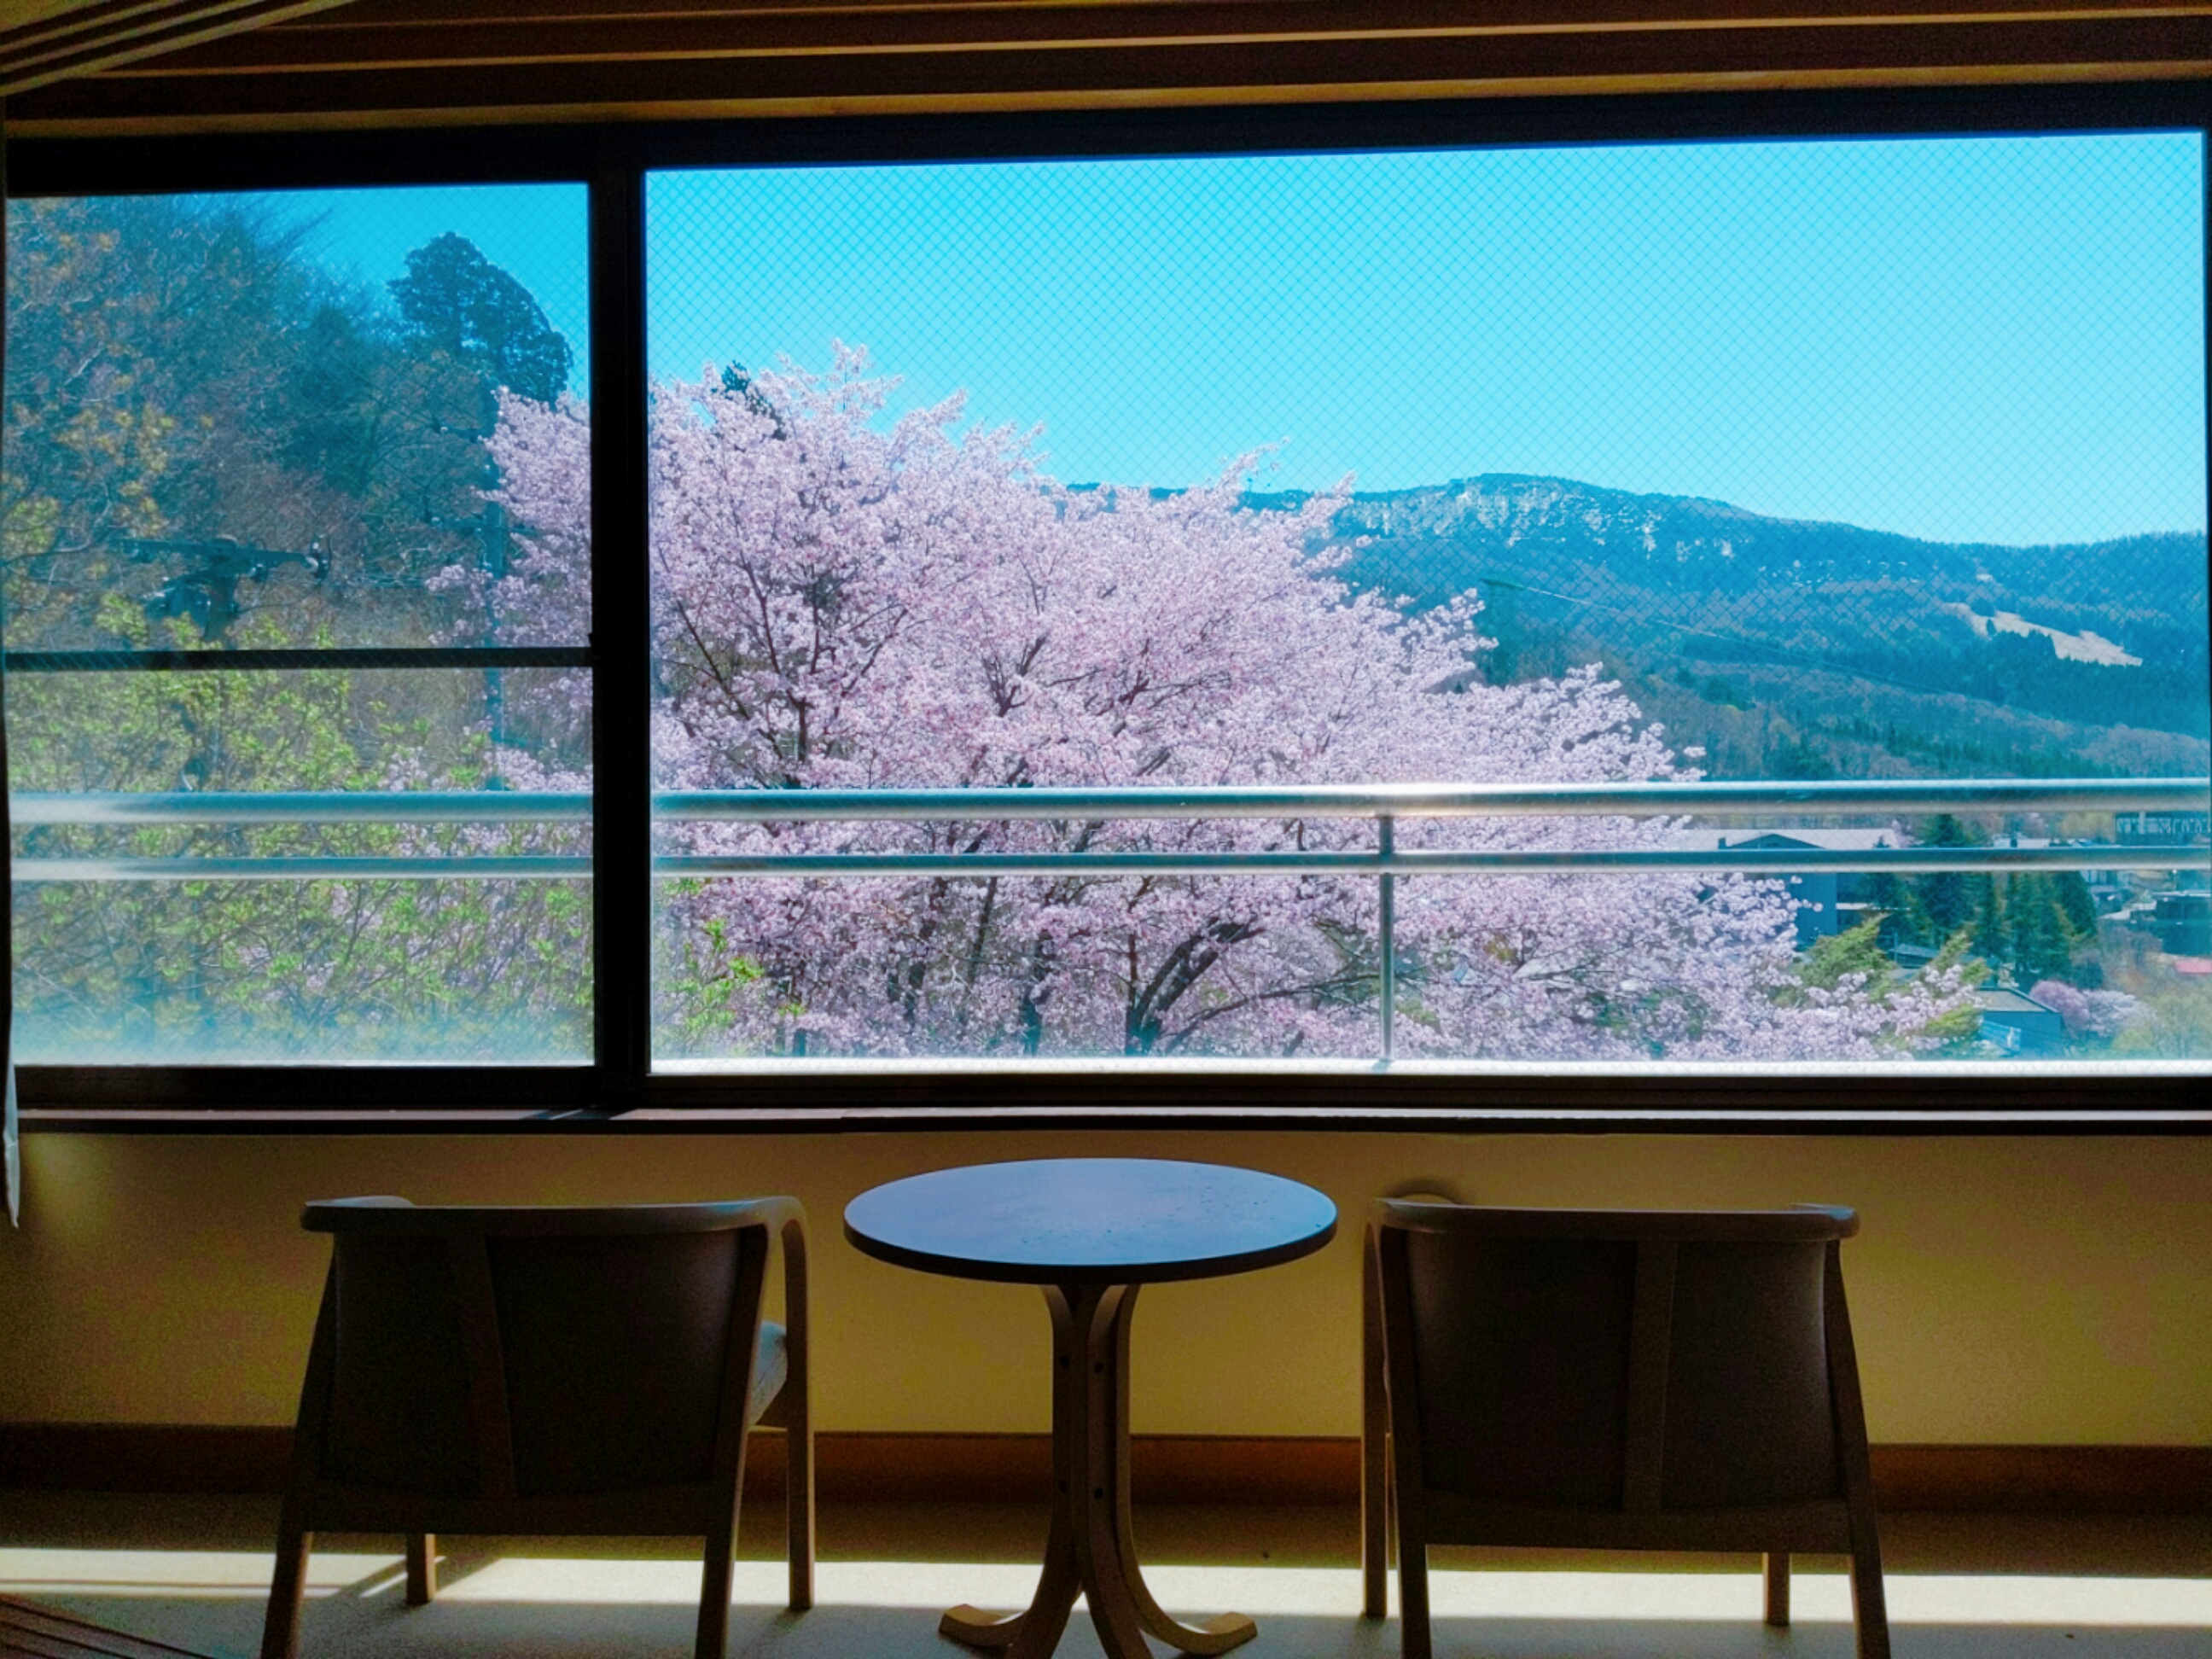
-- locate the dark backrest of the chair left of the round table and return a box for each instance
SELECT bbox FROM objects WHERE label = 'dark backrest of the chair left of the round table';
[301,1199,796,1498]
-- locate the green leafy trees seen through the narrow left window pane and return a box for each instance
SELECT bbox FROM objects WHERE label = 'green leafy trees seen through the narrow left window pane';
[0,199,591,1060]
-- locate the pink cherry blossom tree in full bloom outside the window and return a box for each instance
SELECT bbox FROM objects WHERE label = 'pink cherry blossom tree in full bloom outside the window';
[485,350,1965,1060]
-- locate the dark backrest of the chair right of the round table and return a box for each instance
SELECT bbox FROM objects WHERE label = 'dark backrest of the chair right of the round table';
[1371,1199,1858,1513]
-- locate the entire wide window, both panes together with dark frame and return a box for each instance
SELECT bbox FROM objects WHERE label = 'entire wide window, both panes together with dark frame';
[0,110,2212,1124]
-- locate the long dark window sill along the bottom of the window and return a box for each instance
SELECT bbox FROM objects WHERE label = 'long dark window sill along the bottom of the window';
[22,1060,2212,1135]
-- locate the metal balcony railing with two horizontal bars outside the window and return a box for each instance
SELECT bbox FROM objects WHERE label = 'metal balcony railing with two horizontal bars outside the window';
[11,778,2212,1060]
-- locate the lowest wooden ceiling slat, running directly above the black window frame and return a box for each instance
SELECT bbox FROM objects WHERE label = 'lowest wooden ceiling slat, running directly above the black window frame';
[9,15,2212,131]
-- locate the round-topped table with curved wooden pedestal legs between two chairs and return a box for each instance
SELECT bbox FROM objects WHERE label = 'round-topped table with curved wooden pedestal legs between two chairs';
[845,1157,1336,1659]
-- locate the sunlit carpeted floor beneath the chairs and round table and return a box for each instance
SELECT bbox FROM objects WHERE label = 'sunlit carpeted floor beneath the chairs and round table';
[0,1493,2212,1659]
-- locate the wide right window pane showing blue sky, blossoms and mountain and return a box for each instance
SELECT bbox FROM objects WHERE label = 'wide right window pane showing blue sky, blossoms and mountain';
[648,133,2212,1064]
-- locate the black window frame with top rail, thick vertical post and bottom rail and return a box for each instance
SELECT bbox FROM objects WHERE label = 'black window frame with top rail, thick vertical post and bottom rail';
[7,82,2212,1132]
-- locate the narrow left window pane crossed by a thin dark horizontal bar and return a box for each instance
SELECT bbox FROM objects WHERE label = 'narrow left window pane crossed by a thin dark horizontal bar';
[0,186,591,1064]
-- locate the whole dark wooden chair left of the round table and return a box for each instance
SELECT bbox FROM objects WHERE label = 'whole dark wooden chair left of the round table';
[261,1199,814,1659]
